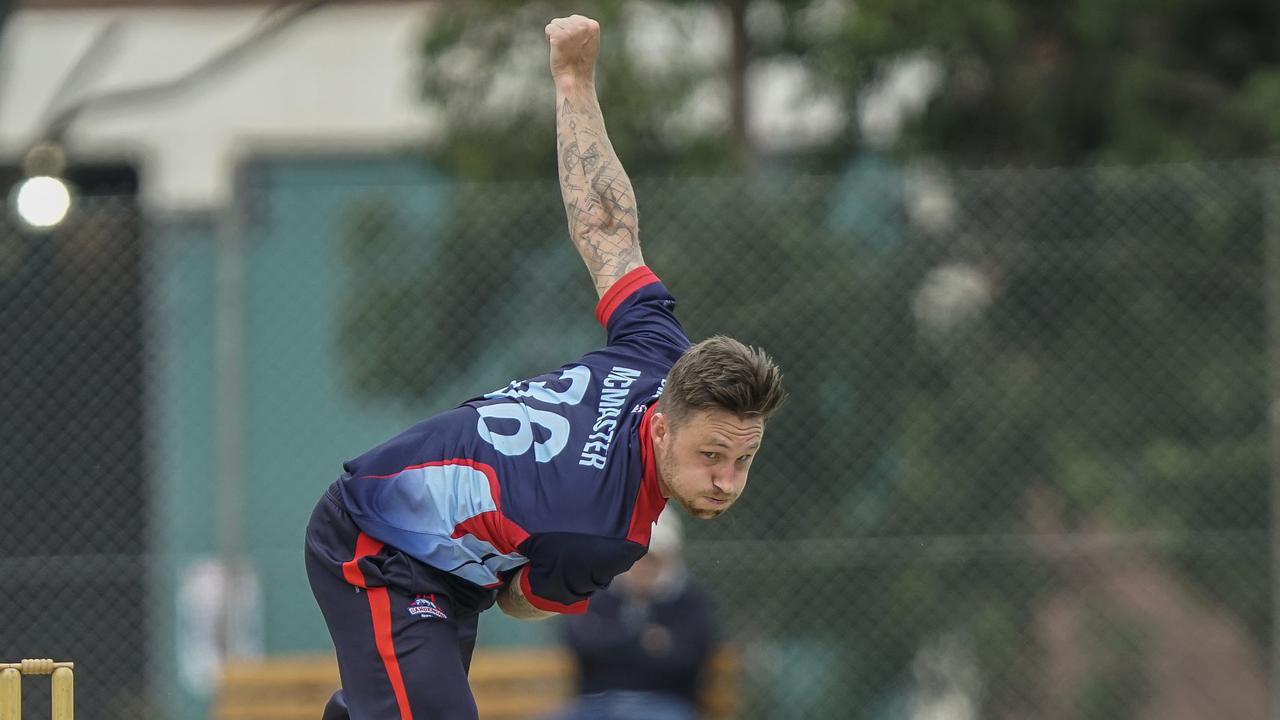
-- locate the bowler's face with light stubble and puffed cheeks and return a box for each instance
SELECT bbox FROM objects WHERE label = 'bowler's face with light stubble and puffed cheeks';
[650,410,764,520]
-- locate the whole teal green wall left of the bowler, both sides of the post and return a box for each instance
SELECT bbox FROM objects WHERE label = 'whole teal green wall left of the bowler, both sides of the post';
[152,159,553,719]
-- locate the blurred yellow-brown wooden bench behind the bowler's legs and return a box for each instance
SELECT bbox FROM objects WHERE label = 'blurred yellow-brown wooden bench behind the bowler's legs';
[212,648,741,720]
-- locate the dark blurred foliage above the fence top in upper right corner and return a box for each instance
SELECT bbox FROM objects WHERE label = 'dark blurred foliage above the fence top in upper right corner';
[809,0,1280,165]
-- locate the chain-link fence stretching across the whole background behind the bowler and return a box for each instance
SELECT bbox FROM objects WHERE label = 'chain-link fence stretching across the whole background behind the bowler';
[0,161,1280,720]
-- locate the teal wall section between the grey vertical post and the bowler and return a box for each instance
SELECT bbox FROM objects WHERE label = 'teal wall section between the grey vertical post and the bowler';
[235,160,439,652]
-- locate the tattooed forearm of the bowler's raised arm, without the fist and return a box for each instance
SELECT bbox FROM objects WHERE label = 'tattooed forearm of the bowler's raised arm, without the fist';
[556,83,644,297]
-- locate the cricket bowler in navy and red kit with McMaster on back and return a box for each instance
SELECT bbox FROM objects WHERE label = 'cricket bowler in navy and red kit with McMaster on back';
[306,15,786,720]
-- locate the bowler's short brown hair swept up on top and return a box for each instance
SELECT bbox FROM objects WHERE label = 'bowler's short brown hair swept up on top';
[658,336,787,425]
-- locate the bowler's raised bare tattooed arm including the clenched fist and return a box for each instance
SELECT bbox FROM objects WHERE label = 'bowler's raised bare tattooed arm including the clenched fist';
[547,15,644,297]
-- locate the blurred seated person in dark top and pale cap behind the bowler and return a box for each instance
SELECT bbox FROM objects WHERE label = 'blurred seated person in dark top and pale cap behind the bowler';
[554,509,719,720]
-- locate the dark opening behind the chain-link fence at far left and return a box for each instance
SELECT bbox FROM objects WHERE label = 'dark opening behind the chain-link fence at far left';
[0,190,152,717]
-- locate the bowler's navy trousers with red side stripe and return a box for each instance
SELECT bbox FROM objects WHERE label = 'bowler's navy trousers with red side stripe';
[306,488,495,720]
